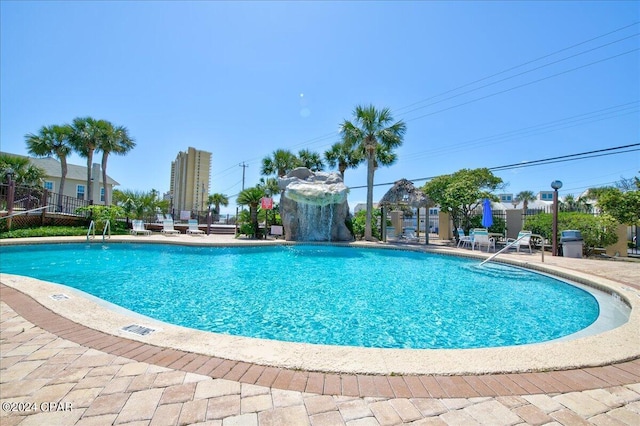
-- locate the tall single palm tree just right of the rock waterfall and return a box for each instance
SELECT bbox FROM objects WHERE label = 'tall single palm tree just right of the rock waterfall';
[340,105,407,241]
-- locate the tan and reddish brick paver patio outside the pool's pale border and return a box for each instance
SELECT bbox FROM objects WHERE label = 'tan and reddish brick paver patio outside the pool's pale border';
[0,236,640,426]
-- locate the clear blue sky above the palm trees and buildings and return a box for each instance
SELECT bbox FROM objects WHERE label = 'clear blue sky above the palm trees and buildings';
[0,1,640,212]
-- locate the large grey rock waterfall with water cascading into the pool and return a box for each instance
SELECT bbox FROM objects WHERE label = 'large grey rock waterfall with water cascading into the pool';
[278,167,353,241]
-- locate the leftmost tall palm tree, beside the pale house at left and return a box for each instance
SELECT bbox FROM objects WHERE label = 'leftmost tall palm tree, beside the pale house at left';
[25,125,73,210]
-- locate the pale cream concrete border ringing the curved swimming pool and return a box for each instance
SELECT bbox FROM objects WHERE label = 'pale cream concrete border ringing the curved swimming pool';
[0,236,640,377]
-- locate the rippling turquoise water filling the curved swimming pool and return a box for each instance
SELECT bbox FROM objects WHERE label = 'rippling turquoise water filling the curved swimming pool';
[0,244,599,349]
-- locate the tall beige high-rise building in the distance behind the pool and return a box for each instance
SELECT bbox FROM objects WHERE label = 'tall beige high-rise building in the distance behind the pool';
[169,147,211,215]
